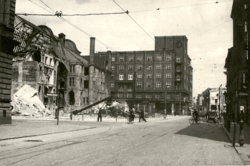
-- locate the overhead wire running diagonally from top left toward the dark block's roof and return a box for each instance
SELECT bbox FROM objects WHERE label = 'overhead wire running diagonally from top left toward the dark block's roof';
[29,0,116,51]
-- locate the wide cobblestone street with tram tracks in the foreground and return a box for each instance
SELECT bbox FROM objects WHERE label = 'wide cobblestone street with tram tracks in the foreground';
[0,117,243,166]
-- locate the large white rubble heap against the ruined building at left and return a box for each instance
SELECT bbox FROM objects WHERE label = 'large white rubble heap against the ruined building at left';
[11,85,51,116]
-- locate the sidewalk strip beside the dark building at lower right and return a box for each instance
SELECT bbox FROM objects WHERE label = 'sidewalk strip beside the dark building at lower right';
[223,124,250,164]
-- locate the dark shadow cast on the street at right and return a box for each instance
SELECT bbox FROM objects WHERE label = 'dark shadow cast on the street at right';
[175,119,230,143]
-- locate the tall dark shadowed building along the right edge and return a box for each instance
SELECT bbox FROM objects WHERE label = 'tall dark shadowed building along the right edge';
[225,0,250,123]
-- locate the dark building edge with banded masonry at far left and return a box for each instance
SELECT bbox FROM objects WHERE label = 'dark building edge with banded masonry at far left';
[0,0,17,124]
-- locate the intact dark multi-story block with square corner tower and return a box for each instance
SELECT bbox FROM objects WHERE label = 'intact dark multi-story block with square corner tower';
[95,36,193,114]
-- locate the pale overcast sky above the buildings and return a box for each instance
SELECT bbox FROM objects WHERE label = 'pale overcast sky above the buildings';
[16,0,233,97]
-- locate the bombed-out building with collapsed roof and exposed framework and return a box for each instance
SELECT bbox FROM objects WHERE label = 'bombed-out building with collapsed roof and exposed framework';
[11,16,110,114]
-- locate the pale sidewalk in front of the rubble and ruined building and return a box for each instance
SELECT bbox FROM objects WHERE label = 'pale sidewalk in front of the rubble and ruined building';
[0,115,185,141]
